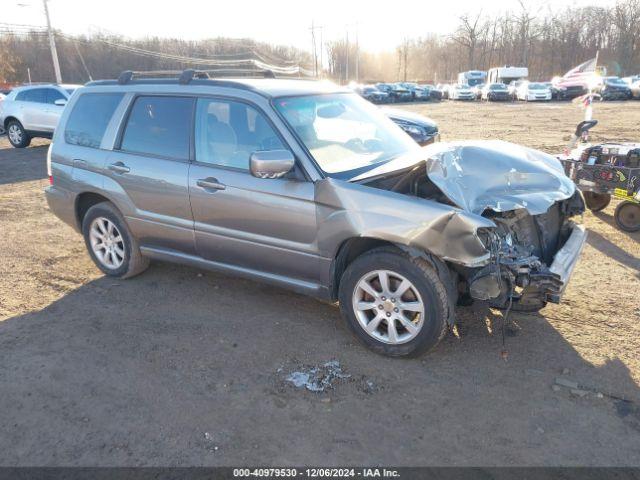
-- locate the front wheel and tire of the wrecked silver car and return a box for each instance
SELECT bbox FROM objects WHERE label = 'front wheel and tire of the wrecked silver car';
[339,247,449,357]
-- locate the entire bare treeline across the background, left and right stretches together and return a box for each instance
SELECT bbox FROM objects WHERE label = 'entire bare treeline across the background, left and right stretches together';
[0,0,640,83]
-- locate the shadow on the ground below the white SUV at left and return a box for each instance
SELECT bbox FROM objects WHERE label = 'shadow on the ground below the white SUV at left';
[0,142,49,185]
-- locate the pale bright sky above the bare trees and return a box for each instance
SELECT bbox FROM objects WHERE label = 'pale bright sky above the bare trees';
[0,0,615,52]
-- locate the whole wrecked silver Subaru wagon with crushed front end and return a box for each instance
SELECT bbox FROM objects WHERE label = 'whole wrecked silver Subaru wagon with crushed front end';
[46,71,585,356]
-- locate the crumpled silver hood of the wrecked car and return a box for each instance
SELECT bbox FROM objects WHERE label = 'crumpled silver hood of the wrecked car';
[423,140,575,215]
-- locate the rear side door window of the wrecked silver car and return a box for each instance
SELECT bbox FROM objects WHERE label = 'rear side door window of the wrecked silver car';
[121,97,194,160]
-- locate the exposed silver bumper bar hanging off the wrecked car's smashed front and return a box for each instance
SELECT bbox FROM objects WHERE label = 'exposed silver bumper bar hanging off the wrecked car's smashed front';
[543,224,587,303]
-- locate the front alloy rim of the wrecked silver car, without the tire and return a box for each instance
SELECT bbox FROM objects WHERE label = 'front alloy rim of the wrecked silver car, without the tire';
[352,270,424,345]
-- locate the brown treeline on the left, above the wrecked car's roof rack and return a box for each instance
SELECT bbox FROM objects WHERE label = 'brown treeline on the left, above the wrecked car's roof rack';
[0,30,310,83]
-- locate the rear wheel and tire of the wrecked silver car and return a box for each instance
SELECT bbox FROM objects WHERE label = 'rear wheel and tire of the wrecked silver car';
[82,202,149,278]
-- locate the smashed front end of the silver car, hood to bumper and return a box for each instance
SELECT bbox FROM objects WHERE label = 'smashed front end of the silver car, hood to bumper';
[427,142,586,310]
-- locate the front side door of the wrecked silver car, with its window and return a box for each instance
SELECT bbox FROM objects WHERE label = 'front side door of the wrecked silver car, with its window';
[189,98,319,282]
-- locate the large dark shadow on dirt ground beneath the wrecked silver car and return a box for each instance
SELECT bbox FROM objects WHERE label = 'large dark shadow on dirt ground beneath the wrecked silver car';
[0,264,640,466]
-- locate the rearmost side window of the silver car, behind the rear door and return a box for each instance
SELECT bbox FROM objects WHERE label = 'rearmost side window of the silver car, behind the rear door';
[64,93,123,148]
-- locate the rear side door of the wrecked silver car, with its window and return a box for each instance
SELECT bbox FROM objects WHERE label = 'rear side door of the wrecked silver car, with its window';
[105,95,195,254]
